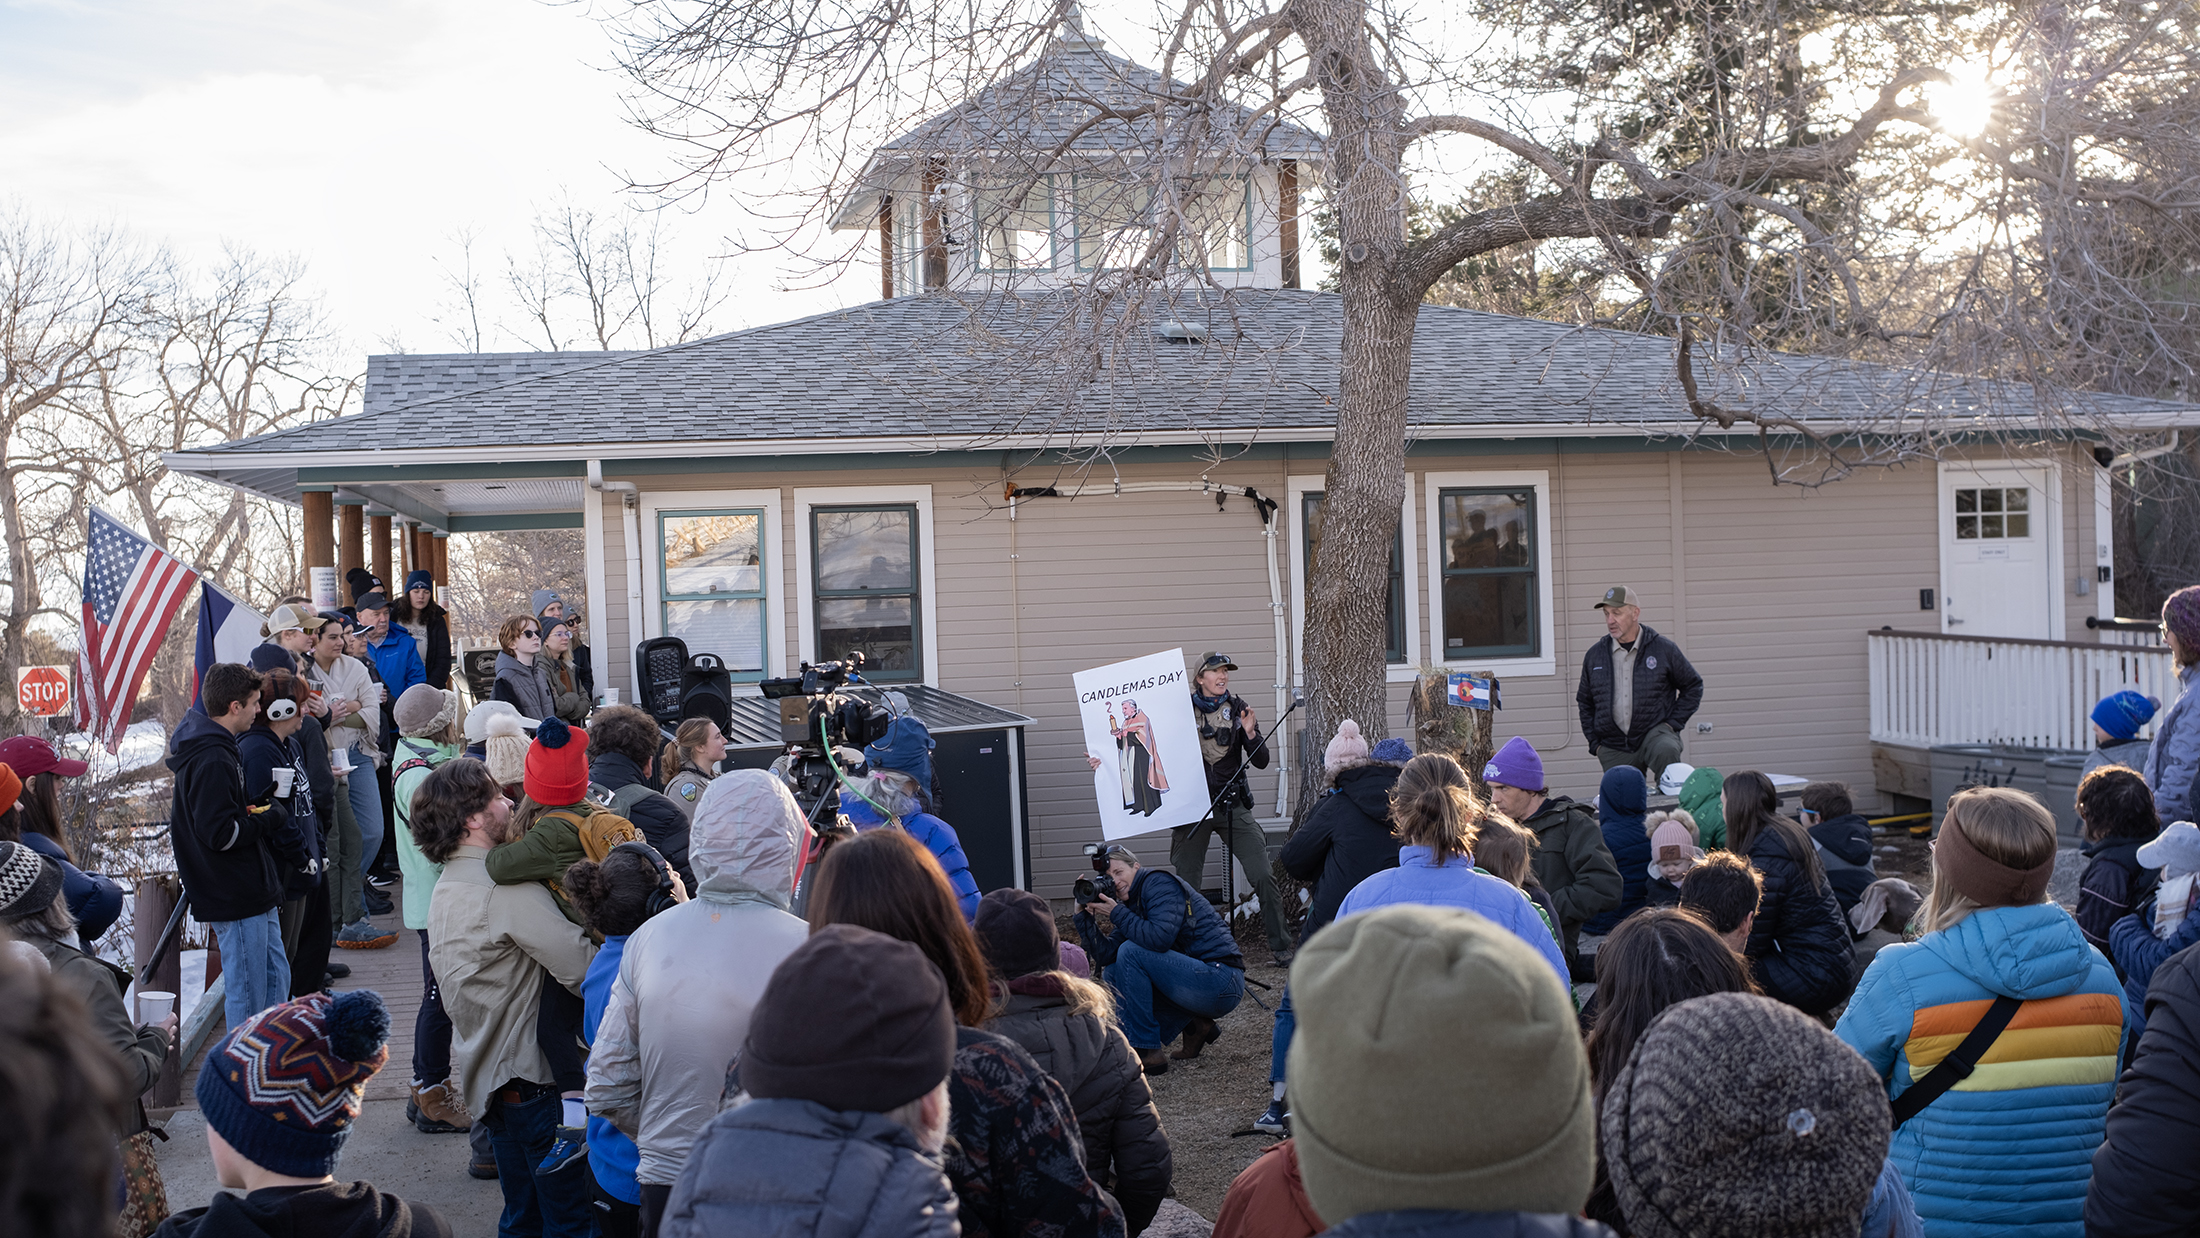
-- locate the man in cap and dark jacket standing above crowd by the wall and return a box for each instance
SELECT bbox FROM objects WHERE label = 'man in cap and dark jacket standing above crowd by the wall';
[1573,585,1703,783]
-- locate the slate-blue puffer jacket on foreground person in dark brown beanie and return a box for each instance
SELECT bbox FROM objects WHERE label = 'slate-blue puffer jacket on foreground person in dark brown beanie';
[658,1099,959,1238]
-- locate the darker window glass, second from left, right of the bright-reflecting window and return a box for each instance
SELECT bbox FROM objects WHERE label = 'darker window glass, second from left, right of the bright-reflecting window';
[810,506,924,679]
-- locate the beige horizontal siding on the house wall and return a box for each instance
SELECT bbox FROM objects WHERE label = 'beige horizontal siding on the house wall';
[603,439,2092,895]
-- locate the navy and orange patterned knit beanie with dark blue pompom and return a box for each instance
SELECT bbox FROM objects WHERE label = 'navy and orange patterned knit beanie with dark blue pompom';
[198,990,389,1179]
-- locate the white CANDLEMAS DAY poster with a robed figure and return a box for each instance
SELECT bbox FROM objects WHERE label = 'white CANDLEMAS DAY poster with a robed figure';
[1071,649,1208,840]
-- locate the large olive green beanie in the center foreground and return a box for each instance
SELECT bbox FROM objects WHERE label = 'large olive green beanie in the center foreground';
[1289,904,1595,1225]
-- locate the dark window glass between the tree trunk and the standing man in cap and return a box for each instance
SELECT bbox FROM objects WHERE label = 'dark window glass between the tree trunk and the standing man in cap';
[1437,488,1542,662]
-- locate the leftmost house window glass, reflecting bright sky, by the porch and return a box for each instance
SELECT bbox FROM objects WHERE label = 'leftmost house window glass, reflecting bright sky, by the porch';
[658,508,766,679]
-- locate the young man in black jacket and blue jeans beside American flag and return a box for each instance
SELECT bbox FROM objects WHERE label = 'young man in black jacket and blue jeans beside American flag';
[167,662,290,1027]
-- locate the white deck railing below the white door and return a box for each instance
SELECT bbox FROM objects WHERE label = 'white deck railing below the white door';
[1866,629,2178,750]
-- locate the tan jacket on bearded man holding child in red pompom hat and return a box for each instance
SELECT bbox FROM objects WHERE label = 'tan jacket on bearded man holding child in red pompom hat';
[427,847,596,1113]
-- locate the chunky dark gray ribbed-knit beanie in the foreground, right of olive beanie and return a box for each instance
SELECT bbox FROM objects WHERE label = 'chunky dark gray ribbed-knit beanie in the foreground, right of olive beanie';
[1602,994,1892,1238]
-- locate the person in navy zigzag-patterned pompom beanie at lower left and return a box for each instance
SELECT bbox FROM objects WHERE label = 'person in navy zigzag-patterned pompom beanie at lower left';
[154,992,451,1238]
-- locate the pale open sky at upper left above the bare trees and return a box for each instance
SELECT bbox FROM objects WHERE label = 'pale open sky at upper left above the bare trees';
[0,0,878,356]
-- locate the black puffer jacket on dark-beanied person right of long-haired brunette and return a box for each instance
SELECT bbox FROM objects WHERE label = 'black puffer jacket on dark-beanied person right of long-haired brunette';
[986,974,1175,1234]
